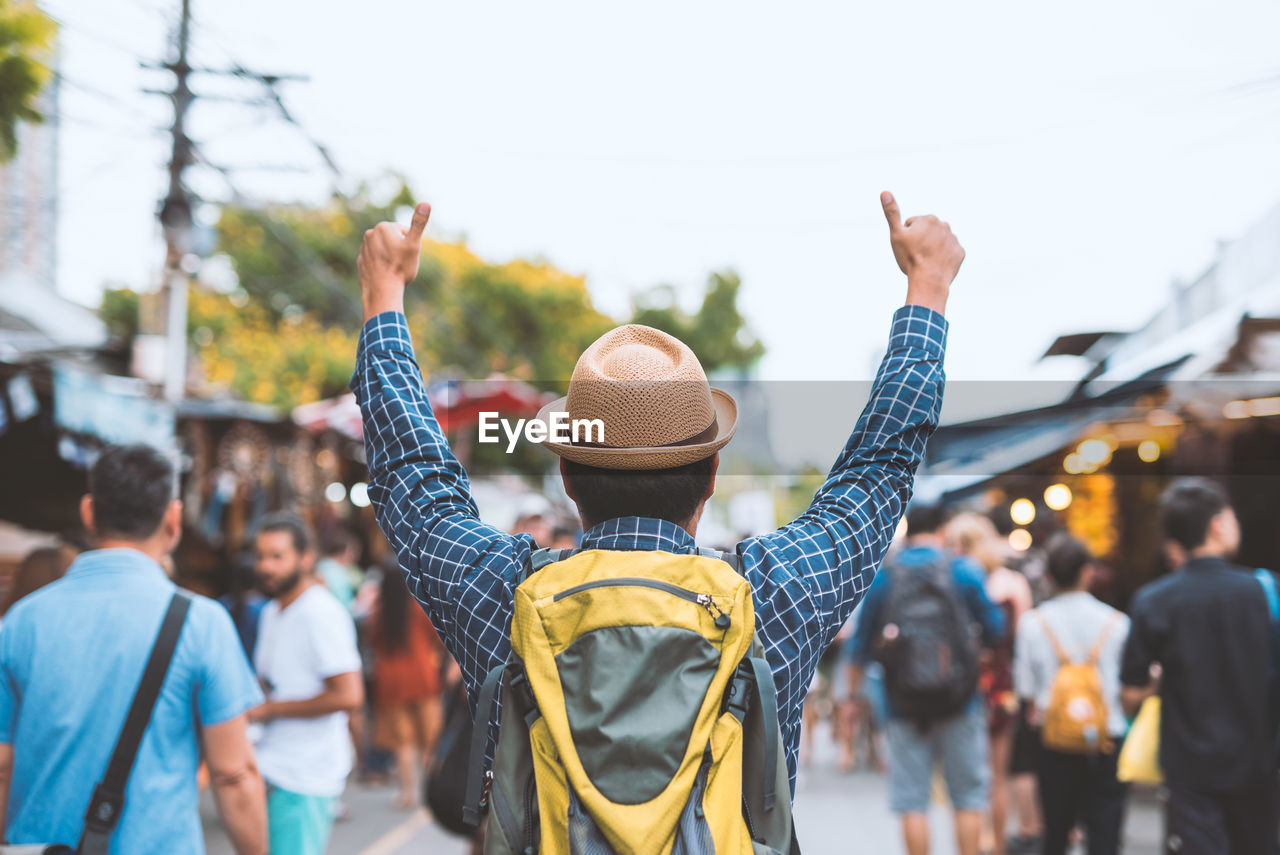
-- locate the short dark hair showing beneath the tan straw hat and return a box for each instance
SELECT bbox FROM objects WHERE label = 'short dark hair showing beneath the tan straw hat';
[564,457,712,526]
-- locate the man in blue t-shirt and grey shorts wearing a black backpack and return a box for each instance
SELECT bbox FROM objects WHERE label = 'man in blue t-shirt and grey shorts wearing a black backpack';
[849,502,1005,855]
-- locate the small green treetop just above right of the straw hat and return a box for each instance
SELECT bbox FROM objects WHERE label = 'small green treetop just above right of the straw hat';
[631,270,764,371]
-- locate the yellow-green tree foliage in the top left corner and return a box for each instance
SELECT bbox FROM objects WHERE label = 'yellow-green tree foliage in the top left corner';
[0,0,58,163]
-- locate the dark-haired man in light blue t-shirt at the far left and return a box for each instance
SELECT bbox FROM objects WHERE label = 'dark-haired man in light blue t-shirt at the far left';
[0,445,266,855]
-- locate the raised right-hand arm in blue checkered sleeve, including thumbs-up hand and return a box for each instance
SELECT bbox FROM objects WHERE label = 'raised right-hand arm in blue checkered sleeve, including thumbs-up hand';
[740,193,964,647]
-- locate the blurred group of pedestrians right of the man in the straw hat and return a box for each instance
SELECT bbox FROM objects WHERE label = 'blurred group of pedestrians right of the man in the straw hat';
[803,479,1280,855]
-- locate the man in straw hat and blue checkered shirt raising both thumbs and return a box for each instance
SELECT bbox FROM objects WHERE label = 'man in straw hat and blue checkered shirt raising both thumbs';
[352,193,964,803]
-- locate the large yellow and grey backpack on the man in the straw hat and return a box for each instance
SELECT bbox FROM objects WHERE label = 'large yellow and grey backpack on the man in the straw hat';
[465,549,797,855]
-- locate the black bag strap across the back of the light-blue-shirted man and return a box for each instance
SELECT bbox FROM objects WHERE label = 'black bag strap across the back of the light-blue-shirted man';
[76,591,191,855]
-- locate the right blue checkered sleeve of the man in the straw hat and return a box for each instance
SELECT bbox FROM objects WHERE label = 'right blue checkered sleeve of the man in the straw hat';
[739,306,947,787]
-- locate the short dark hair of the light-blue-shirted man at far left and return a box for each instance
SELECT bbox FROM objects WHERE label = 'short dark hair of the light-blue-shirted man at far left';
[88,444,178,540]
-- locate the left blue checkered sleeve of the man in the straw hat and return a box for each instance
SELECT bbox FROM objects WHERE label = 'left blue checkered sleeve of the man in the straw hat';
[351,312,531,698]
